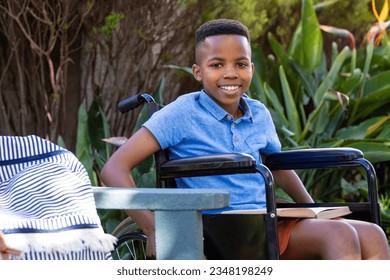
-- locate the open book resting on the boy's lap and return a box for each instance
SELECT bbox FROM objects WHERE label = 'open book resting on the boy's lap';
[221,206,352,219]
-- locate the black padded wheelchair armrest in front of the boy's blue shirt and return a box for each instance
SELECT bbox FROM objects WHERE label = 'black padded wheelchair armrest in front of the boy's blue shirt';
[158,153,256,179]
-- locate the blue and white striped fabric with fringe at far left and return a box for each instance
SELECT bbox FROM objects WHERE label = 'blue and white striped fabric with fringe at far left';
[0,135,115,260]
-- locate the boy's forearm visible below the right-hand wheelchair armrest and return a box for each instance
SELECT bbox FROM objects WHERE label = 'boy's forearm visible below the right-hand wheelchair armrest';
[272,170,314,203]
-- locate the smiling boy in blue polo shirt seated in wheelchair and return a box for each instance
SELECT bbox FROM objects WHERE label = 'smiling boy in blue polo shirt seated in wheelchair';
[102,19,389,259]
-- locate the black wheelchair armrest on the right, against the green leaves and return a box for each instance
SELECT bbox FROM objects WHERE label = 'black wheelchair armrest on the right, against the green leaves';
[265,148,363,170]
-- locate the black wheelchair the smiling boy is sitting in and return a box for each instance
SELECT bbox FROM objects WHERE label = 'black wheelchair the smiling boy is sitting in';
[112,93,380,260]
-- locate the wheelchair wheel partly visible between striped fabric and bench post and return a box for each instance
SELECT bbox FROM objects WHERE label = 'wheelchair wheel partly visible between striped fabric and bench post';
[112,217,146,260]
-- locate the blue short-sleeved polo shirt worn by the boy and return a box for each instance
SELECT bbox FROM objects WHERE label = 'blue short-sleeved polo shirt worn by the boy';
[144,90,281,213]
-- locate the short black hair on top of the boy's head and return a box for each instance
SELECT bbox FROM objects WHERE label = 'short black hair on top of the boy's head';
[195,19,249,45]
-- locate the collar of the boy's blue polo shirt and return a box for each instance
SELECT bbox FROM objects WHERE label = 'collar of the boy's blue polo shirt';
[199,90,252,122]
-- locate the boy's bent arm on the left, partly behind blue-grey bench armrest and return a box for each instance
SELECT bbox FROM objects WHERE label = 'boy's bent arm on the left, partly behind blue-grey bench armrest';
[101,127,160,257]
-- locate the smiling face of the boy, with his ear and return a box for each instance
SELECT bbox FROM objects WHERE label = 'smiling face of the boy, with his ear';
[192,35,254,115]
